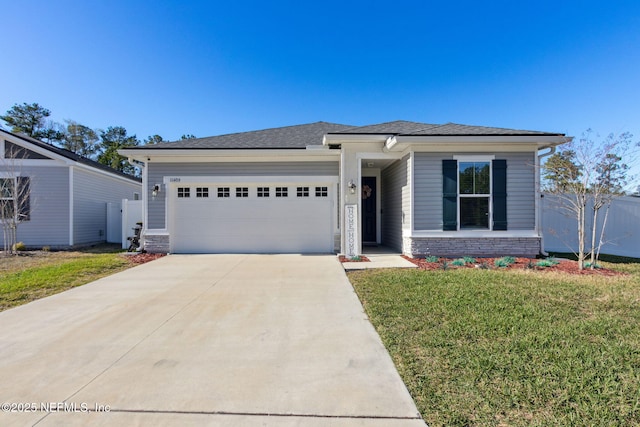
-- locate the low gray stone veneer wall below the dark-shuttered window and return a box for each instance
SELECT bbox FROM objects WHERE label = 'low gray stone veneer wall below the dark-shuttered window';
[404,237,540,257]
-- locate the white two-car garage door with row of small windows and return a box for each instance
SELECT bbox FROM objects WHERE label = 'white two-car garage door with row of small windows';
[169,182,334,253]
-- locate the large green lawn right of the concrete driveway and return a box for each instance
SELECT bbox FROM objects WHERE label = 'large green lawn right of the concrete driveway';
[349,264,640,426]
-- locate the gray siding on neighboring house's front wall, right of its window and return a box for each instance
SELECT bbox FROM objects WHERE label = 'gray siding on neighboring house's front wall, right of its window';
[18,166,69,248]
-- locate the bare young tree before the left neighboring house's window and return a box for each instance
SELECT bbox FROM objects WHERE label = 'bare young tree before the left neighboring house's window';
[0,141,32,254]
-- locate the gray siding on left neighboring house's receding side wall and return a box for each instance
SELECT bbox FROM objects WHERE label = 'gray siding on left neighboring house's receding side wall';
[73,168,142,245]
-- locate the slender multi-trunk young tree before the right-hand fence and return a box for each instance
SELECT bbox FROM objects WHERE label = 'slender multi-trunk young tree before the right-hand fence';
[542,130,632,269]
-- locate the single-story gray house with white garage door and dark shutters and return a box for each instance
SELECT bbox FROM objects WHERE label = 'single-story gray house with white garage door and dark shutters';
[120,121,569,256]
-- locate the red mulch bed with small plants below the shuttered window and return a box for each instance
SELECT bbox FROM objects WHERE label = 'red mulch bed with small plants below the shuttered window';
[403,255,625,276]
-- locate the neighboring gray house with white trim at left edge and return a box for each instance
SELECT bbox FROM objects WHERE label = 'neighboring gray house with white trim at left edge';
[0,129,142,249]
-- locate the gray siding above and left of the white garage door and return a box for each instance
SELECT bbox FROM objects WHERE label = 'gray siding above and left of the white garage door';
[146,161,339,229]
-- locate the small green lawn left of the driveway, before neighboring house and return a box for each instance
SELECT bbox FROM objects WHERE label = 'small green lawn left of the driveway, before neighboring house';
[0,251,131,311]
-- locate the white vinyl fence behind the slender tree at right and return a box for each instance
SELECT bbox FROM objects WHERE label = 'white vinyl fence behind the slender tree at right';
[541,194,640,258]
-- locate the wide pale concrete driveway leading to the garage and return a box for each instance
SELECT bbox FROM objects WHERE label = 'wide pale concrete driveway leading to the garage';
[0,255,425,427]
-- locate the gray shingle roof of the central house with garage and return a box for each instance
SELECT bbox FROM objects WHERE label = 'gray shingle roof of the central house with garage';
[130,120,562,150]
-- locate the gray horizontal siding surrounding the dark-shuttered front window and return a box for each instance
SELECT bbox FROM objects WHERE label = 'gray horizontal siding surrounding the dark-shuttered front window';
[413,152,536,230]
